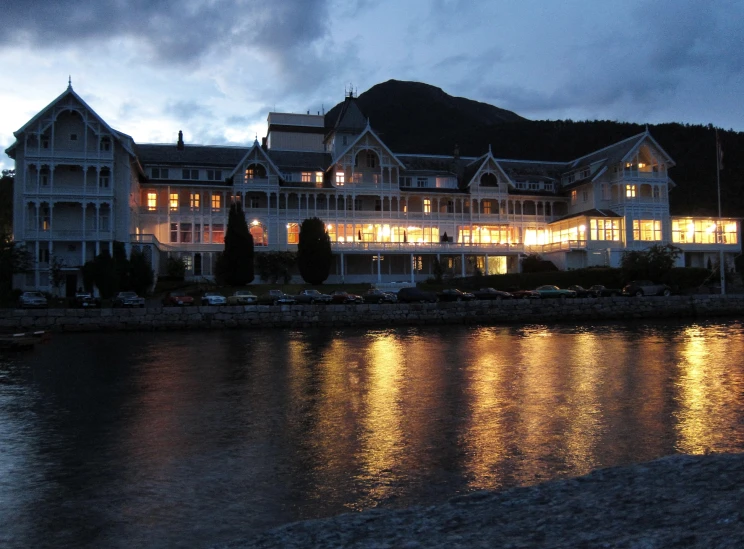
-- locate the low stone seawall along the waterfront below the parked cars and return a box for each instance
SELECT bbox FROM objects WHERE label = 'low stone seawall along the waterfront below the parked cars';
[0,294,744,332]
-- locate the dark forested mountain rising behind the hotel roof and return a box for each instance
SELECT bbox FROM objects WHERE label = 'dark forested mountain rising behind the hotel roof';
[326,80,744,217]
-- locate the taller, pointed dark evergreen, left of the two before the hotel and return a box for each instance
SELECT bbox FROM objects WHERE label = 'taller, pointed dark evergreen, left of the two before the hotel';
[216,202,254,286]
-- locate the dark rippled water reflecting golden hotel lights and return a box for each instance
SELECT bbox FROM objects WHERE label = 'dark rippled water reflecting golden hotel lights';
[0,321,744,548]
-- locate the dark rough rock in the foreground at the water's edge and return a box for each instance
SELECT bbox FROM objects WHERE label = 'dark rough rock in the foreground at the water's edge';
[220,454,744,549]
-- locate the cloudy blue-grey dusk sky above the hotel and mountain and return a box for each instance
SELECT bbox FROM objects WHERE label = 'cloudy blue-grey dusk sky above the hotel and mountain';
[0,0,744,168]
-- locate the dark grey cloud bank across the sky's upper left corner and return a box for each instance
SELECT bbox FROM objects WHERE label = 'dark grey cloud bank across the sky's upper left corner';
[0,0,328,64]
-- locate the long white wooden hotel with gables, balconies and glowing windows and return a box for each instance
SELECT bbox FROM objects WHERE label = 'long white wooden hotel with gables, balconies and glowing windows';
[6,82,741,293]
